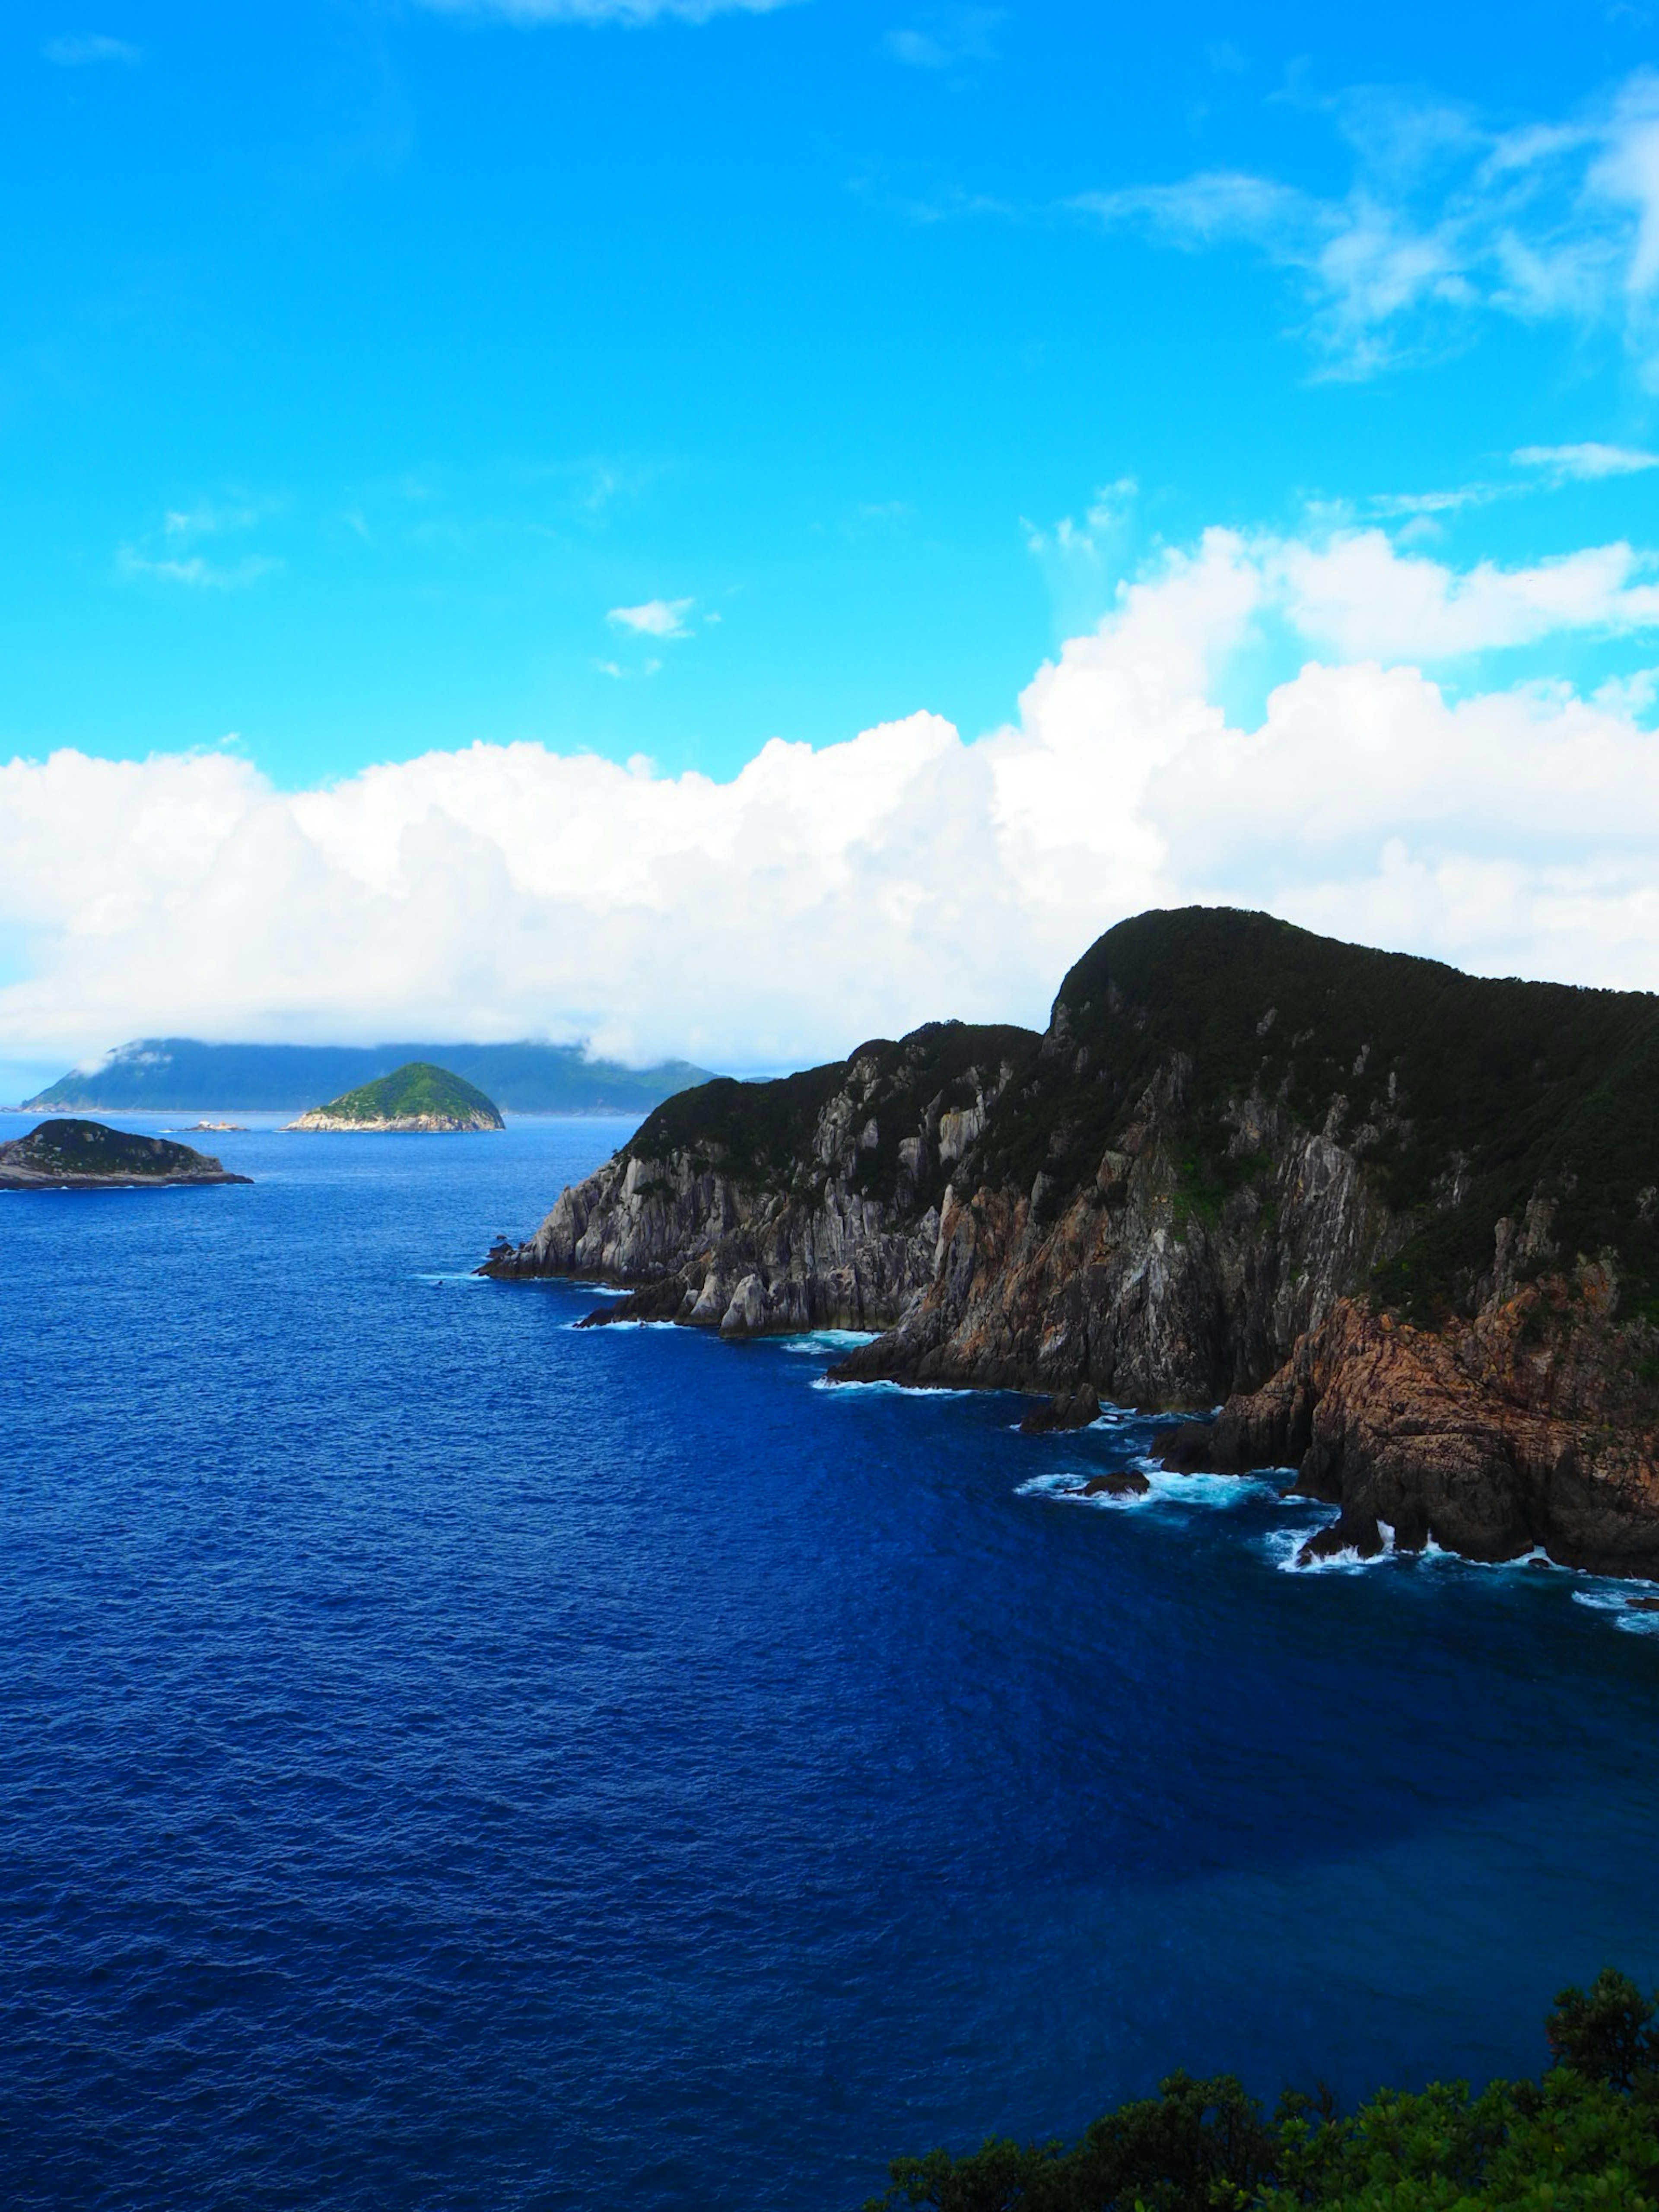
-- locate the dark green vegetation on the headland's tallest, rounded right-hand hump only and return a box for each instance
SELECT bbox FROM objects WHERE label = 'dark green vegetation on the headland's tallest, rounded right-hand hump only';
[976,907,1659,1319]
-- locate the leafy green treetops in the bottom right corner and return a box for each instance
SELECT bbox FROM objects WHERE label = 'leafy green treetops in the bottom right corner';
[865,1971,1659,2212]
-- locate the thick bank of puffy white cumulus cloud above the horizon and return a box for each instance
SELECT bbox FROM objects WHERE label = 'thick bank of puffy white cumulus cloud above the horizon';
[0,531,1659,1066]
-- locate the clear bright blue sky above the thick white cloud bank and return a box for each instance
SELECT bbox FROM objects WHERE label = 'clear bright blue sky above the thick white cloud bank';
[0,0,1659,781]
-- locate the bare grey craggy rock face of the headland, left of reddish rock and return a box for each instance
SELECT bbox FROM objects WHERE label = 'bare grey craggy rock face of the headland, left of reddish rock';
[484,1009,1398,1407]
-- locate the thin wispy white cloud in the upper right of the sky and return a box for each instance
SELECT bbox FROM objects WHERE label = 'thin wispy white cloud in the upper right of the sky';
[1075,69,1659,381]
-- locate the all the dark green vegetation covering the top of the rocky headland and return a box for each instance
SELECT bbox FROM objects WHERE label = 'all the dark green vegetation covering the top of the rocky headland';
[626,907,1659,1323]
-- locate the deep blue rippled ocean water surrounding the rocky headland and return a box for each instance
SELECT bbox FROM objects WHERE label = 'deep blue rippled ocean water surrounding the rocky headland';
[0,1117,1659,2212]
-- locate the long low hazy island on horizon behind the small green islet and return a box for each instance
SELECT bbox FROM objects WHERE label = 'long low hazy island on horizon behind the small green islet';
[22,1037,710,1115]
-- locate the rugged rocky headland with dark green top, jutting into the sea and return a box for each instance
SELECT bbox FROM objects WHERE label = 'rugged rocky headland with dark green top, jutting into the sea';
[486,909,1659,1566]
